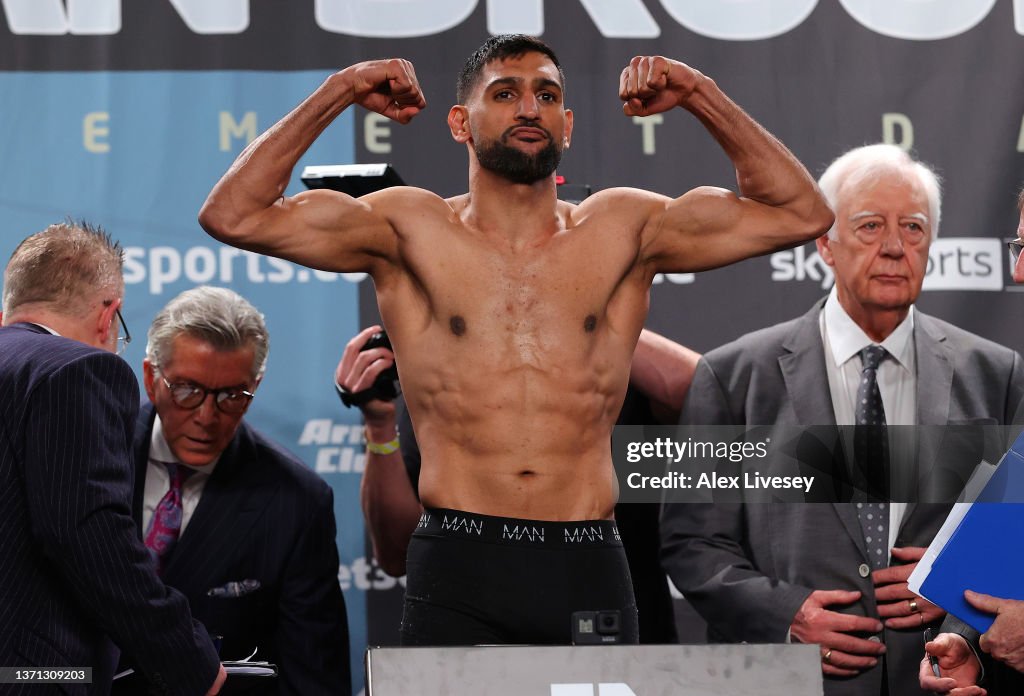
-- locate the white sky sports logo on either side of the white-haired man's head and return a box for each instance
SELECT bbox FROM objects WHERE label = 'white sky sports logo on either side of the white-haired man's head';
[769,236,1010,291]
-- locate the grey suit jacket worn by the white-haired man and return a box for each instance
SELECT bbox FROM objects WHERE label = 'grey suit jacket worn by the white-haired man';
[662,303,1024,696]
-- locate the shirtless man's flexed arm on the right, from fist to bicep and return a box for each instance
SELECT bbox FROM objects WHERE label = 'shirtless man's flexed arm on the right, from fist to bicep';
[618,55,833,272]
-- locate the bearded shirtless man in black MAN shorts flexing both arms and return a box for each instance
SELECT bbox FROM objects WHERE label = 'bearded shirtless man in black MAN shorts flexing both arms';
[200,35,833,645]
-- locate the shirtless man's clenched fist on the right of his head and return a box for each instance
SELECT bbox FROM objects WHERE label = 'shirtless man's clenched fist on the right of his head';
[618,55,705,116]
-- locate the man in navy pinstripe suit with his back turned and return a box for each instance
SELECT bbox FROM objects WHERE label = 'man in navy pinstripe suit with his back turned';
[0,221,224,695]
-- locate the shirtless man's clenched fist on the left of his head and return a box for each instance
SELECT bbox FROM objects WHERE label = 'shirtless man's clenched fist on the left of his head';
[341,58,427,124]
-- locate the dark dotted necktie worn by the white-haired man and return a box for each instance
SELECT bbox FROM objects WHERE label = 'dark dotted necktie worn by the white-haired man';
[853,345,889,569]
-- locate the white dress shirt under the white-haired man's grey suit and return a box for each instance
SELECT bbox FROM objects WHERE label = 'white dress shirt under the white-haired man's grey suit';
[820,288,918,549]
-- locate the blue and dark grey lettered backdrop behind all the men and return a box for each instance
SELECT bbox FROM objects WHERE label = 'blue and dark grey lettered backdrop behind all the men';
[0,0,1024,682]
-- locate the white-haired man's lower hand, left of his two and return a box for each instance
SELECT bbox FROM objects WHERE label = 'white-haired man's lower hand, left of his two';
[790,590,886,677]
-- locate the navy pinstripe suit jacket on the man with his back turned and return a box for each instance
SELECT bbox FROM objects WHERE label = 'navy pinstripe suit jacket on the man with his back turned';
[0,323,217,695]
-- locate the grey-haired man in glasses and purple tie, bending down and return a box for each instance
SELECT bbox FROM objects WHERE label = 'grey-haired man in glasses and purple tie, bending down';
[118,287,351,695]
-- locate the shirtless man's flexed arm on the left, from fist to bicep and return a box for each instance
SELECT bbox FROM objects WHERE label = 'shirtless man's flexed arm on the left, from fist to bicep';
[199,58,426,271]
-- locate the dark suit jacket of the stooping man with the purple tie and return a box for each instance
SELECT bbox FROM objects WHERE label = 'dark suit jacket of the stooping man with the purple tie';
[126,404,351,696]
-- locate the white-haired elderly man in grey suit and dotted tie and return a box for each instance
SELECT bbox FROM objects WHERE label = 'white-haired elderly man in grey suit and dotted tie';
[662,145,1024,696]
